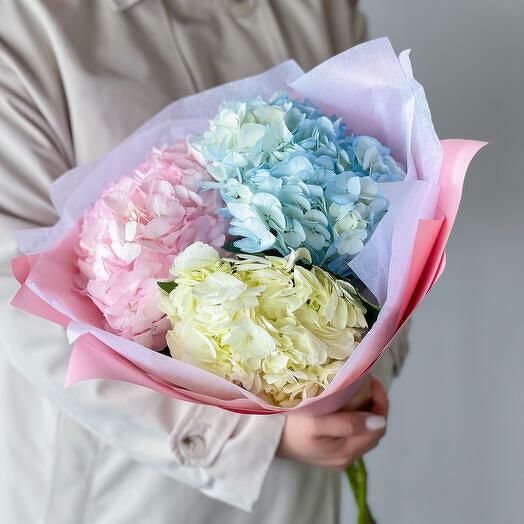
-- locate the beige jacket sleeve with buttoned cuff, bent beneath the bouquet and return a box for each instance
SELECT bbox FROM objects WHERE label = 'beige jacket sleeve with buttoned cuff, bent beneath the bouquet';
[0,62,284,509]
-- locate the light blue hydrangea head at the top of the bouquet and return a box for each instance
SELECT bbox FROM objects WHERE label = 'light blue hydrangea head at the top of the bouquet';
[191,92,405,276]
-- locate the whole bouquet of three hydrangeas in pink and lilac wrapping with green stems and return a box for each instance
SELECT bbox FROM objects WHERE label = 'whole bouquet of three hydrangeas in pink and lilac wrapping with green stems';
[13,39,483,522]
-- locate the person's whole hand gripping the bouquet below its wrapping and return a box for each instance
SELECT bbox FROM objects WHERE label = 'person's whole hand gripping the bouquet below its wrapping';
[277,378,389,470]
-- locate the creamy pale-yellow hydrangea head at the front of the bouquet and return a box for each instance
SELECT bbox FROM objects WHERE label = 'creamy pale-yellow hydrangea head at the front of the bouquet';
[161,242,367,406]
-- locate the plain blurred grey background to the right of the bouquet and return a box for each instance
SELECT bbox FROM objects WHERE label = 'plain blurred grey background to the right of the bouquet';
[348,0,524,524]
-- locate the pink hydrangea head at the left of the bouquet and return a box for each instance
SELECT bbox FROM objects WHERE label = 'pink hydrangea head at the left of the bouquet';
[78,141,227,350]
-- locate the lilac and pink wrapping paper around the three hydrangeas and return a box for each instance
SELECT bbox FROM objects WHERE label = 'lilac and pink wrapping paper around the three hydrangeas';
[13,38,484,414]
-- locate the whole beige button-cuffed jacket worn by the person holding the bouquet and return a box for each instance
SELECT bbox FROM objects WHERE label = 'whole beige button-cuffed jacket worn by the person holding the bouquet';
[0,0,407,524]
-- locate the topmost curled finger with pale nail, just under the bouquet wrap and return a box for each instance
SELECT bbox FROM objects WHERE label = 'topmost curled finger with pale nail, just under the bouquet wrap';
[315,411,386,438]
